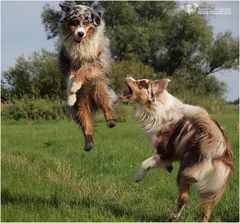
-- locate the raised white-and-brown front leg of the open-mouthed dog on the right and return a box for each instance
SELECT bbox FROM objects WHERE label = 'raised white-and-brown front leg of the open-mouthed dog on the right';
[133,154,171,182]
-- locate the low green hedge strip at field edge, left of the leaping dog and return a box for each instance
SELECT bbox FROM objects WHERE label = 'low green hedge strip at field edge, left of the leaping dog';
[2,99,67,120]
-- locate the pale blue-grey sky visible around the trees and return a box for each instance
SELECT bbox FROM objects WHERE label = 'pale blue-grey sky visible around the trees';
[1,1,239,100]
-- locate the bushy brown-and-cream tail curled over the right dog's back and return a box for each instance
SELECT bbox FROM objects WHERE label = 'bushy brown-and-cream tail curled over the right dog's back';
[182,105,226,159]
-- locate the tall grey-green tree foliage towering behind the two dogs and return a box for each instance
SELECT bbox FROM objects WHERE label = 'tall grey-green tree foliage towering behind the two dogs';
[42,1,239,76]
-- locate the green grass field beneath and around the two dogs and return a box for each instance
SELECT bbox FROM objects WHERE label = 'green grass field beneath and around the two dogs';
[1,109,239,222]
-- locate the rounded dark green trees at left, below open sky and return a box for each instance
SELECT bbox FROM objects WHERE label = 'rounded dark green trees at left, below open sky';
[1,50,65,98]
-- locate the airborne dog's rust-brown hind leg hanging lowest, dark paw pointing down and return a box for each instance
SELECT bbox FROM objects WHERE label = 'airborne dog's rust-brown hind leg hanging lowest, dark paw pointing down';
[77,93,94,151]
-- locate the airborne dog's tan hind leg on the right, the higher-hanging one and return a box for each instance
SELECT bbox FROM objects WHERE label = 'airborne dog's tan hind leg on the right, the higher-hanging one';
[93,81,116,128]
